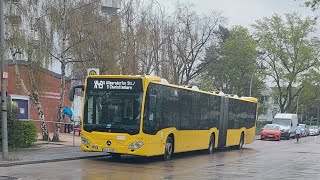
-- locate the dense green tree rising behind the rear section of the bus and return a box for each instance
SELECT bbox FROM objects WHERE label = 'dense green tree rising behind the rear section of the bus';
[205,26,262,96]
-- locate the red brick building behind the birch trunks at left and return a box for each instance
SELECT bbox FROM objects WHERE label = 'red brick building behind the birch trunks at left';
[3,61,71,132]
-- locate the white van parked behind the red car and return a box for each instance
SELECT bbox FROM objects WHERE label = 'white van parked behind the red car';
[272,113,298,140]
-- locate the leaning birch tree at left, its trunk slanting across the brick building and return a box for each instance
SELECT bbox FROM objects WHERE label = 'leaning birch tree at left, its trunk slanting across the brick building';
[6,0,50,140]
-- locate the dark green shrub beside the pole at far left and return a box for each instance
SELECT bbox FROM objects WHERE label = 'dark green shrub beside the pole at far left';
[0,103,37,149]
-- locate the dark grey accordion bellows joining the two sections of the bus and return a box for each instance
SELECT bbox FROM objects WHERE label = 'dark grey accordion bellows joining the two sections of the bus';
[218,96,229,148]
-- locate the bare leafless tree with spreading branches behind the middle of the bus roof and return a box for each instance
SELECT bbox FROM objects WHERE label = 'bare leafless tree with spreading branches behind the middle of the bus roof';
[173,5,224,84]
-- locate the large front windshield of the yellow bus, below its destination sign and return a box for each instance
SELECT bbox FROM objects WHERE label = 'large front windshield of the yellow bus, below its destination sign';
[83,78,142,135]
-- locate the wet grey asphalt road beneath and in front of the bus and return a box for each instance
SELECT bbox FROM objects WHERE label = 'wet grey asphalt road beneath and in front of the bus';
[0,136,320,180]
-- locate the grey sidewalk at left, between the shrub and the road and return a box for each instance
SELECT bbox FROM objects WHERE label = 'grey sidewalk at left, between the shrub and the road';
[0,134,106,167]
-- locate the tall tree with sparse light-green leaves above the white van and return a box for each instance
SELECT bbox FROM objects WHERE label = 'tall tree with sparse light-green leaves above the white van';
[253,13,320,112]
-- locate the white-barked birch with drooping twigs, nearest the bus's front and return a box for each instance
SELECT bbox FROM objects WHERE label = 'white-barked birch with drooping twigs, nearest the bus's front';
[47,0,108,141]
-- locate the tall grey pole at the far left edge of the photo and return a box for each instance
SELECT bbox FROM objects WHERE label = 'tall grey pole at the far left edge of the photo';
[0,0,8,160]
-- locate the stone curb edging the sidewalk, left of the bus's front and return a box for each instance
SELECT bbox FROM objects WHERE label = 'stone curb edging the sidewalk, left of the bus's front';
[0,154,107,167]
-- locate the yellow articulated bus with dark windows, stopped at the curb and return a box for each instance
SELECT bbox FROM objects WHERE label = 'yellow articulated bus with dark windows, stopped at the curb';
[70,75,257,160]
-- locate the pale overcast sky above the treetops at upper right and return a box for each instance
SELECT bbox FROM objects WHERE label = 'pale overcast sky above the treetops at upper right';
[157,0,320,28]
